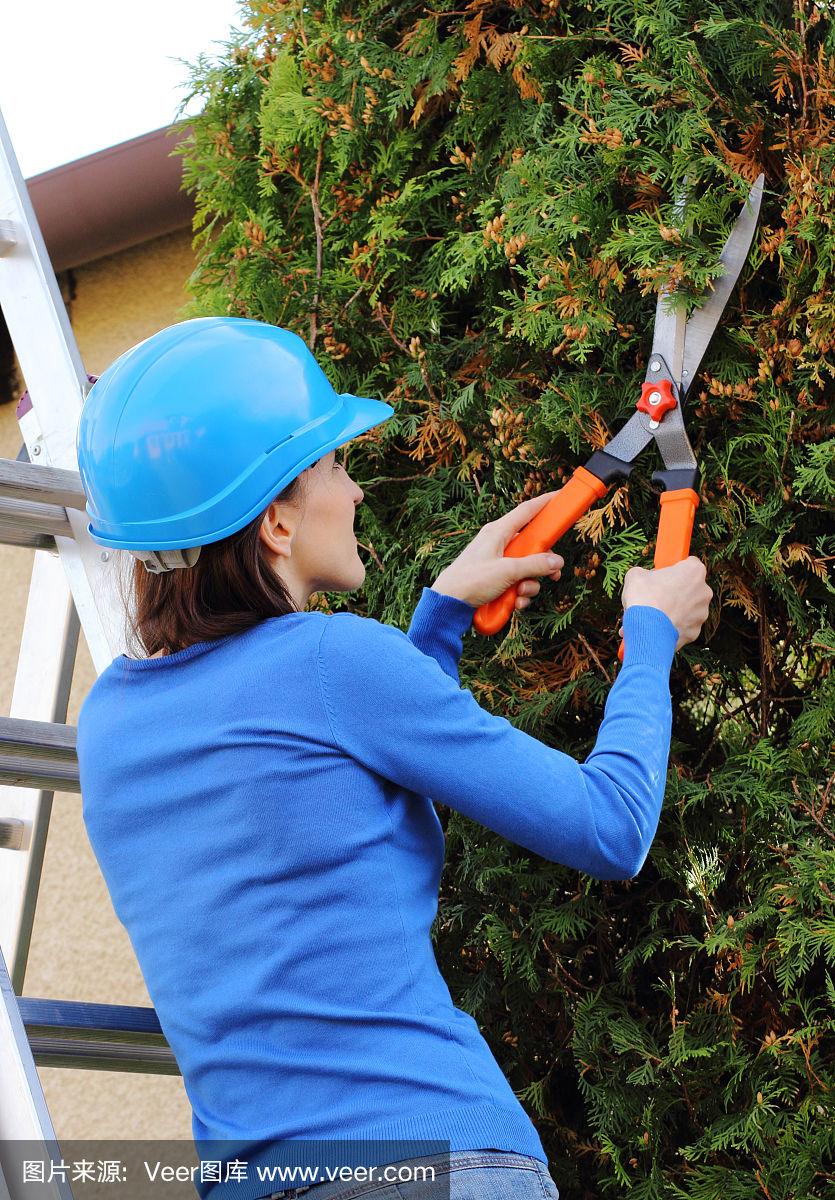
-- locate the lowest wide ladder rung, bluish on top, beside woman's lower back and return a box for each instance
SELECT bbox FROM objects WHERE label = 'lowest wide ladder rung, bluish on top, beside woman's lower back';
[18,996,180,1075]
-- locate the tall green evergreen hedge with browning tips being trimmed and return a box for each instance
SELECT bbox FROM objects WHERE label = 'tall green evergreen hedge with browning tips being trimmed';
[172,0,835,1200]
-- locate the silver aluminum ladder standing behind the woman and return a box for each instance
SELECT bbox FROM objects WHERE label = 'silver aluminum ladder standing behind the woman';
[0,105,180,1200]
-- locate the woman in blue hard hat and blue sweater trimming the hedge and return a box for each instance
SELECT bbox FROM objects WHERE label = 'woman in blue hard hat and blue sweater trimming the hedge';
[78,318,711,1200]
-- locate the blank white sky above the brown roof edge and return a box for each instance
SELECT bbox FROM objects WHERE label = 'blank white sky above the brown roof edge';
[0,0,242,178]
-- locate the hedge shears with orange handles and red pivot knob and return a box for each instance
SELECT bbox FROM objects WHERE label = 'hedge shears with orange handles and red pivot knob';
[473,175,764,662]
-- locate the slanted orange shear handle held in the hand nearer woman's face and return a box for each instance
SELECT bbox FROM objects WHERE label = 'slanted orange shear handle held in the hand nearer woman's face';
[473,467,607,635]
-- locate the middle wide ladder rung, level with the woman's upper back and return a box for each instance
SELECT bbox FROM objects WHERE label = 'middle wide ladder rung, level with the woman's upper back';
[0,716,82,792]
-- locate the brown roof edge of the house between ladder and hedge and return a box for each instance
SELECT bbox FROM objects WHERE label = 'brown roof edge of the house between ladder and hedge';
[26,124,194,271]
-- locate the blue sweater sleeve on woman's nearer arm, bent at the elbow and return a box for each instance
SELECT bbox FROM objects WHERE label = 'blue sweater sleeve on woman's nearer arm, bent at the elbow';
[318,605,678,880]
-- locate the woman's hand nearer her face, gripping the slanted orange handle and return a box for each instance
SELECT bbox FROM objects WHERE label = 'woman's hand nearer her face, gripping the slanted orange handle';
[432,492,565,611]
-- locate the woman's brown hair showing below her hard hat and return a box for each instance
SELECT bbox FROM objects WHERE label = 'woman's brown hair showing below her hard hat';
[122,472,305,658]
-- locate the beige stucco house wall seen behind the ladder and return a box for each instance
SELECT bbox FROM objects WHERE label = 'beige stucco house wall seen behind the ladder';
[0,229,194,1140]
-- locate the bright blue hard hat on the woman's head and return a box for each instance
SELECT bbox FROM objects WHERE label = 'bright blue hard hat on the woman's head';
[77,317,395,552]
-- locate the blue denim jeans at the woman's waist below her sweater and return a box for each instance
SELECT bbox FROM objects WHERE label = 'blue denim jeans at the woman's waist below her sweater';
[264,1150,559,1200]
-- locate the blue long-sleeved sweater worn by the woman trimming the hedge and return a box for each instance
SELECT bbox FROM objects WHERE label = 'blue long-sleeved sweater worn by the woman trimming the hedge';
[78,588,678,1200]
